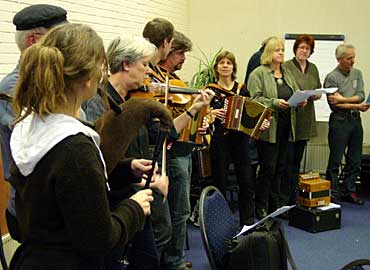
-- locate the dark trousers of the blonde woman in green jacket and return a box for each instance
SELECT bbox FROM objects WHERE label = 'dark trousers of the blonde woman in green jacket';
[256,124,290,213]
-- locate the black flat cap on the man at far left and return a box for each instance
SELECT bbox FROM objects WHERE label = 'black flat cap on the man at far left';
[13,4,67,30]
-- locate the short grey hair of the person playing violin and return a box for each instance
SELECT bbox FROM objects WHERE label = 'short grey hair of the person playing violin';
[107,35,156,74]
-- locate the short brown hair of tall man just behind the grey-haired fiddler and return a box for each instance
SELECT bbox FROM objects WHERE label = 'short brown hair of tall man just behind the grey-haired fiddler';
[143,18,175,48]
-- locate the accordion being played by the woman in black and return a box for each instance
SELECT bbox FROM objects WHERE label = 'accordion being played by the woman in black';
[223,95,272,140]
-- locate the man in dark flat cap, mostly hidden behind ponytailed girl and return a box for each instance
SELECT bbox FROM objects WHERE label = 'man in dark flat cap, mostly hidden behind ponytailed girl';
[0,4,67,240]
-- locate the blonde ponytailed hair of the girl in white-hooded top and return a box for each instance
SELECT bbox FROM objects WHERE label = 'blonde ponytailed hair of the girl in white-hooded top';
[13,24,107,122]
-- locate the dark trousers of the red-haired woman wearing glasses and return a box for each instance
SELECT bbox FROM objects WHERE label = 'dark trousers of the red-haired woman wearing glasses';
[281,140,307,205]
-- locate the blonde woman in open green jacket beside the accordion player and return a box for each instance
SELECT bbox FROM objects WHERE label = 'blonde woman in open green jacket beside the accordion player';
[247,37,304,218]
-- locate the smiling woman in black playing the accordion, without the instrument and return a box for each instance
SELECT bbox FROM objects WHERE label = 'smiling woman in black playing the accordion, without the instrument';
[207,51,255,225]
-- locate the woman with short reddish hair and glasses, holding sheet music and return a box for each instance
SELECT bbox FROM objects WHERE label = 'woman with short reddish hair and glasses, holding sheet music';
[281,35,321,205]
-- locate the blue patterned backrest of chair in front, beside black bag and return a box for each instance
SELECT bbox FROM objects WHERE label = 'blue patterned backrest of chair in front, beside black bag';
[199,186,238,270]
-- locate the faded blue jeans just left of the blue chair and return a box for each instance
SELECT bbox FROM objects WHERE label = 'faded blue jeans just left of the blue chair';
[167,154,192,270]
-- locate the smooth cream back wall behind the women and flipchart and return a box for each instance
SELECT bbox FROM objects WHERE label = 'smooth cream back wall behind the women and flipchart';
[186,0,370,144]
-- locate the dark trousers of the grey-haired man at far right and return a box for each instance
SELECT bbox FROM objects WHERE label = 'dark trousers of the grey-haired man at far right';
[326,111,363,196]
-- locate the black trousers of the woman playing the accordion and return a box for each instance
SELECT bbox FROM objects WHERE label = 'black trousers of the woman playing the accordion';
[210,131,255,224]
